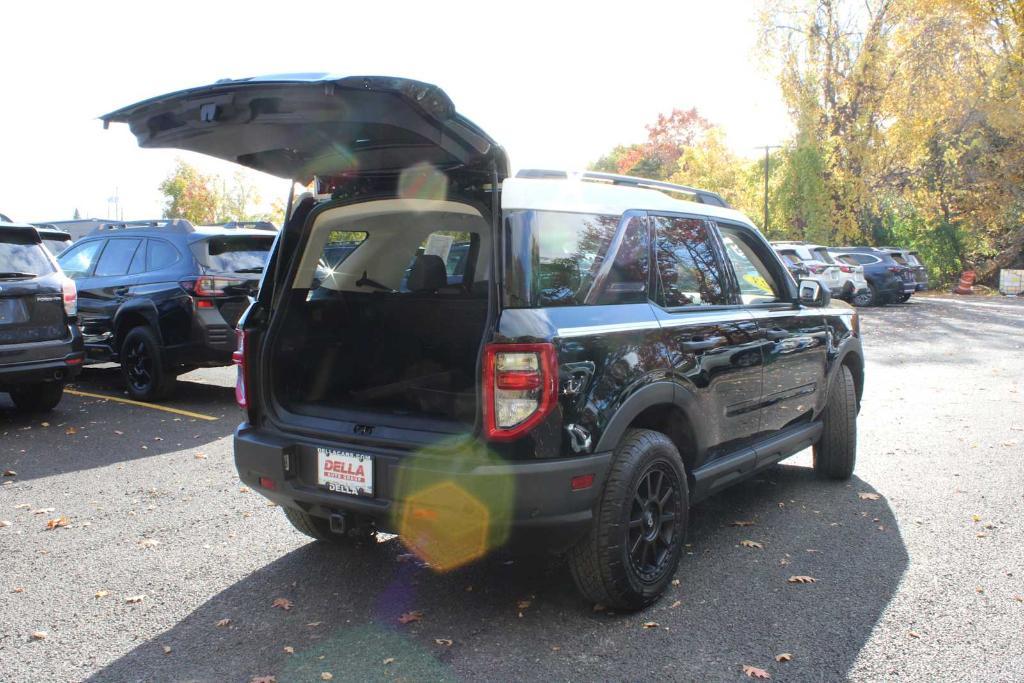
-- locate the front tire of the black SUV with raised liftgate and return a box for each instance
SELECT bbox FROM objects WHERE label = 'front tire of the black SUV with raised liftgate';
[814,366,857,479]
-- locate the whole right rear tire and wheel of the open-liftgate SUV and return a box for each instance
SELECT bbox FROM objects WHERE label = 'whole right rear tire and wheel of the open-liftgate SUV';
[567,429,689,609]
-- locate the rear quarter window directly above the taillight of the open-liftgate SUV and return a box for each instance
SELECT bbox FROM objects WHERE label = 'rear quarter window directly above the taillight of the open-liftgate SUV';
[505,211,621,308]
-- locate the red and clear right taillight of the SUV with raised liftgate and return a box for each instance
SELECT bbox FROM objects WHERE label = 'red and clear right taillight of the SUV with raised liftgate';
[483,344,558,441]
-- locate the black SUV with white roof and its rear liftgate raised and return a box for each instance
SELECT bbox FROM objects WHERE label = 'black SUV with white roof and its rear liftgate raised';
[103,76,863,608]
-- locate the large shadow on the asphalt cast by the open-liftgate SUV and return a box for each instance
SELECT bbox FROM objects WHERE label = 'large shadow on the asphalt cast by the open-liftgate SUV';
[91,466,907,681]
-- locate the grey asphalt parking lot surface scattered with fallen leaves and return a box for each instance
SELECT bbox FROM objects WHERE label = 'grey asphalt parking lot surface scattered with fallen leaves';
[0,296,1024,681]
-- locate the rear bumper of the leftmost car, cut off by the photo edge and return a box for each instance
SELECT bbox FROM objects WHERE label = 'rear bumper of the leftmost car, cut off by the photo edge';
[0,326,85,391]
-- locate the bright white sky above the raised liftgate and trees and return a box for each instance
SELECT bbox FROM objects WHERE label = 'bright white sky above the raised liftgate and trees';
[0,0,791,221]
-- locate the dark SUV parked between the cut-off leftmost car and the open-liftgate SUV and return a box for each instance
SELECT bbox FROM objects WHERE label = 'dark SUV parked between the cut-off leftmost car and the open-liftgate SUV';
[58,220,274,400]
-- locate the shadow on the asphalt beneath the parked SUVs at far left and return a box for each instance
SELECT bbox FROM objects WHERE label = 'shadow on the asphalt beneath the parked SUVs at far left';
[0,368,234,481]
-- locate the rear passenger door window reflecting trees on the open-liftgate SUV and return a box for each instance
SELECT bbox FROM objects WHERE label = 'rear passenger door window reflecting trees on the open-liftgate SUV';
[653,216,730,308]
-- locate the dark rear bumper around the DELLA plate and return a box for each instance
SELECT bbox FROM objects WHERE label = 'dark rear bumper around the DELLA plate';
[234,424,611,552]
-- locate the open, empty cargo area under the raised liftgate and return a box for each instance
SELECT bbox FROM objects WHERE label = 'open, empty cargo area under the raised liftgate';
[267,200,490,425]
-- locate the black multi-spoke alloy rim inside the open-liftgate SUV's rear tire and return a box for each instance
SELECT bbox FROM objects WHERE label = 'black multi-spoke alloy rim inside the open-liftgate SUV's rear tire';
[628,462,682,582]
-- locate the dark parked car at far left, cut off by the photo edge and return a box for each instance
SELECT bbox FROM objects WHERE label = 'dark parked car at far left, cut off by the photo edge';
[0,222,85,411]
